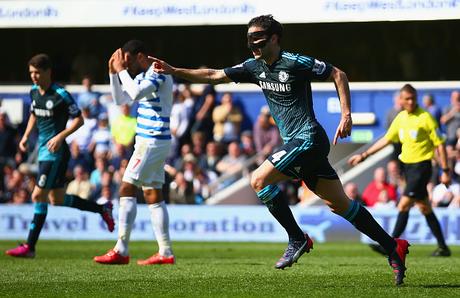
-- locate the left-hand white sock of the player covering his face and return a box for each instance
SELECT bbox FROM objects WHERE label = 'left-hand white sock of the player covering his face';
[114,197,137,256]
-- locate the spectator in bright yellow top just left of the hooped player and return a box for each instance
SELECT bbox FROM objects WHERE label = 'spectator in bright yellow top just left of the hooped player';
[111,104,137,152]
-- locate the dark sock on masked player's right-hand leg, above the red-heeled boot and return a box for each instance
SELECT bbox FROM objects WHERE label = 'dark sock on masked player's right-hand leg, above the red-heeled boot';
[342,200,396,254]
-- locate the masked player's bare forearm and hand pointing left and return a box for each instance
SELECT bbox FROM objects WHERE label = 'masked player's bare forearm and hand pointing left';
[148,56,232,85]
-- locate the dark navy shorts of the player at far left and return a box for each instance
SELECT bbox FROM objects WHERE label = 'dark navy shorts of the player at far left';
[37,153,70,189]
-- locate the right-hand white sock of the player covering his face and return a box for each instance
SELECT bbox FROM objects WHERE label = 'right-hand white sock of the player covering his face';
[149,201,173,256]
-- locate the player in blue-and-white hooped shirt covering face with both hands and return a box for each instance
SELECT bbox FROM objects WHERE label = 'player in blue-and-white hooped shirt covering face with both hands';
[94,40,175,265]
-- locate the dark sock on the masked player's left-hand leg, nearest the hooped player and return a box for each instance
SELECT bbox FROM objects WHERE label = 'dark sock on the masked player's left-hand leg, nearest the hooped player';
[257,185,305,240]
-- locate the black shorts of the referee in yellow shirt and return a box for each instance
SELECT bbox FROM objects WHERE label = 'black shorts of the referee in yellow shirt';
[403,160,432,200]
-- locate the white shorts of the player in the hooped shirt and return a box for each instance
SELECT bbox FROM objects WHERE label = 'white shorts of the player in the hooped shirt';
[123,138,171,189]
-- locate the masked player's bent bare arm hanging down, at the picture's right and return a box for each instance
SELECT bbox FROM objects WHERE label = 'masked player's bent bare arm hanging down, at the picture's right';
[330,67,353,145]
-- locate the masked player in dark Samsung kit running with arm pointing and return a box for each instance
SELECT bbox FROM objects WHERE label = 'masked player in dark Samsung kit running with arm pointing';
[151,15,409,285]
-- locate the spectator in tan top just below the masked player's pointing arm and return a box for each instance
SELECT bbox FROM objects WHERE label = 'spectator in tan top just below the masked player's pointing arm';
[212,92,243,143]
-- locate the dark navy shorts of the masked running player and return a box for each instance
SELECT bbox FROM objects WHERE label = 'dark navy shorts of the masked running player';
[267,137,339,190]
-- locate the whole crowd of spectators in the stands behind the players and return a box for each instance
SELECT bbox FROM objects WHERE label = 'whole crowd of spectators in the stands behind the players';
[0,77,460,208]
